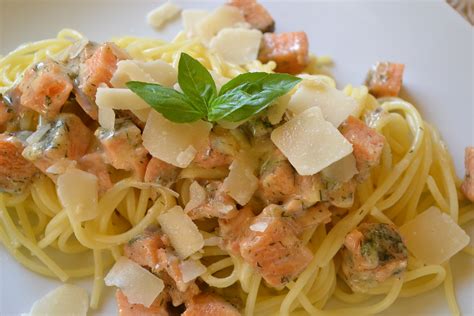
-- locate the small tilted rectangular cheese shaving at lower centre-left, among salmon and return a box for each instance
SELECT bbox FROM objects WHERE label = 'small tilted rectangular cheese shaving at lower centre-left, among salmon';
[158,206,204,259]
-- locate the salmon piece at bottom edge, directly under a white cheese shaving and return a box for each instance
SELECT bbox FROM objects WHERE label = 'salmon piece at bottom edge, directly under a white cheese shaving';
[115,290,169,316]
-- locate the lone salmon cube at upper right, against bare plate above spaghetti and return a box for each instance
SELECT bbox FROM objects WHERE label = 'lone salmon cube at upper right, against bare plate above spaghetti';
[366,62,405,98]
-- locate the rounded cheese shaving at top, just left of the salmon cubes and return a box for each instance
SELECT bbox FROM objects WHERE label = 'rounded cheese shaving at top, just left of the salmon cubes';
[210,28,262,65]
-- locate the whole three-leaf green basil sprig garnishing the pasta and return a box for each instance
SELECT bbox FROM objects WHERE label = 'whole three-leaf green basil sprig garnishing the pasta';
[127,53,301,123]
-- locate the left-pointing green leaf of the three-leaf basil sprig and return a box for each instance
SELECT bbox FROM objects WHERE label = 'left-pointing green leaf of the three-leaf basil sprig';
[127,81,206,123]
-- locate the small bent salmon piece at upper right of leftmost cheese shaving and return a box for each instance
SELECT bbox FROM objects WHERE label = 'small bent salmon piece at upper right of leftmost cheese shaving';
[77,151,113,194]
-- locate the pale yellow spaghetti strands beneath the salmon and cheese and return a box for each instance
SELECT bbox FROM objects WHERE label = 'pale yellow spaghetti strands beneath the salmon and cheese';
[0,24,474,316]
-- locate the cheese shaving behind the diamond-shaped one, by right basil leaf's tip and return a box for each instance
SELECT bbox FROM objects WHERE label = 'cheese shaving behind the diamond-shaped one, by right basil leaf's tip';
[288,80,358,127]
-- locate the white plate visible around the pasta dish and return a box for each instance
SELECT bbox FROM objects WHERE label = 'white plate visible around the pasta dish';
[0,0,474,315]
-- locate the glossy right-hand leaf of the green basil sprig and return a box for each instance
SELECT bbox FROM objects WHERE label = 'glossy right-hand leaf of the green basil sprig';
[208,72,301,122]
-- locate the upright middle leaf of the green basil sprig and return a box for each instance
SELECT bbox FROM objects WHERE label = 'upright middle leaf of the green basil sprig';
[178,53,217,110]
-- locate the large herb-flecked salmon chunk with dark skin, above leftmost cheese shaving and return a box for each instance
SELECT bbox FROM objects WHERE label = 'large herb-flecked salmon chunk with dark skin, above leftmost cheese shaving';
[23,113,92,173]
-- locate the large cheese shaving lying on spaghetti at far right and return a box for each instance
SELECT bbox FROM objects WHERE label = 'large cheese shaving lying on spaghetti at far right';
[400,206,470,264]
